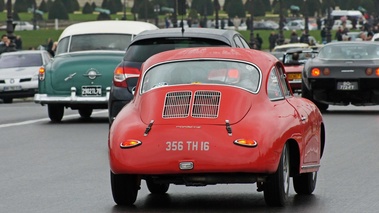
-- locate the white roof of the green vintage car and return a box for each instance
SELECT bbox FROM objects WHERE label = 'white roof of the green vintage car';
[59,20,158,40]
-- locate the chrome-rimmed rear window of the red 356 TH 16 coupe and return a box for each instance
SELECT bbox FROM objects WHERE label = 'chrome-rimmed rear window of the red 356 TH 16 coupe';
[141,60,261,93]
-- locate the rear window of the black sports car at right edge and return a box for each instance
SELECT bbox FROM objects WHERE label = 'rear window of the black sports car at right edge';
[319,42,379,60]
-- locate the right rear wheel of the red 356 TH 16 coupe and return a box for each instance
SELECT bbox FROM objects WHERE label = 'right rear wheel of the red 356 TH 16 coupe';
[263,145,290,206]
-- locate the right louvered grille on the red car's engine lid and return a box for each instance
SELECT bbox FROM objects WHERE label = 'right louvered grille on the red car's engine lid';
[192,91,221,118]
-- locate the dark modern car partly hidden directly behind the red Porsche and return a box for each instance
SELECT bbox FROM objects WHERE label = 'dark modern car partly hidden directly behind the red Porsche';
[108,28,250,123]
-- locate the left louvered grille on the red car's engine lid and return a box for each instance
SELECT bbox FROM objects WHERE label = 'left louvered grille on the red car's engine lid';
[163,91,192,118]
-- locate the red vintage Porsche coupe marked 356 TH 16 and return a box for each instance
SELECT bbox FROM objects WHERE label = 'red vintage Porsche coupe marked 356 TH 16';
[108,47,325,206]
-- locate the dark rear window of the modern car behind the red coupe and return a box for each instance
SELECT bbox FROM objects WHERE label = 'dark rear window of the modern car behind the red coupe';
[124,38,230,62]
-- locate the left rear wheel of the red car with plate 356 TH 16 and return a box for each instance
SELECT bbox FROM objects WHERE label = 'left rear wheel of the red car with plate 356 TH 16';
[111,172,139,206]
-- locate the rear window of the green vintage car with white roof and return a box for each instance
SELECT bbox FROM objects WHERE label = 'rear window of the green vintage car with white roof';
[57,34,132,54]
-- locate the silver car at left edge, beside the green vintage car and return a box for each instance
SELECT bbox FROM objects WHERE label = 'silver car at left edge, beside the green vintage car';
[0,50,51,103]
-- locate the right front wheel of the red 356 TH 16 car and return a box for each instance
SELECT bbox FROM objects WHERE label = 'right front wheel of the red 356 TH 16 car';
[293,172,317,195]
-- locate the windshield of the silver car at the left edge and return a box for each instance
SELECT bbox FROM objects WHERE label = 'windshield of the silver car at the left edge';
[0,53,42,68]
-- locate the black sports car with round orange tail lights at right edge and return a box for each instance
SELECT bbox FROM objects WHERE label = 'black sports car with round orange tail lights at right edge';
[302,41,379,110]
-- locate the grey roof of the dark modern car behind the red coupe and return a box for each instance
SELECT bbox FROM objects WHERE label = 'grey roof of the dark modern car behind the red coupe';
[132,28,239,44]
